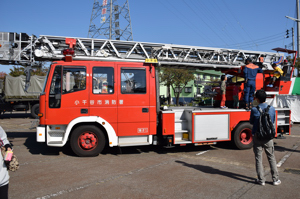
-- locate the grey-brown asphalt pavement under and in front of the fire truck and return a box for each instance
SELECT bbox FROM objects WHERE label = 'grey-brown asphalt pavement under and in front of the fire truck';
[0,113,300,199]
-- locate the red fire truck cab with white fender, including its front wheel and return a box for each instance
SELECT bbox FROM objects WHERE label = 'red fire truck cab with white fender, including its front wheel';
[38,61,157,156]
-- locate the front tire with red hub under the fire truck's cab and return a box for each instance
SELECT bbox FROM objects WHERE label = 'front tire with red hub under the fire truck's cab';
[70,126,106,157]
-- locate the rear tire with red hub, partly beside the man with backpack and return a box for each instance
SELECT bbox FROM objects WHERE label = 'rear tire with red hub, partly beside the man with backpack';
[232,122,253,150]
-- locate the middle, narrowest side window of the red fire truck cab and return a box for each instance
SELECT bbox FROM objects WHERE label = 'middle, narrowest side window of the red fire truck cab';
[93,67,114,94]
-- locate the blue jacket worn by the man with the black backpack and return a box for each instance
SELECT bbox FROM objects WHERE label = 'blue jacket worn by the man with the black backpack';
[250,103,275,135]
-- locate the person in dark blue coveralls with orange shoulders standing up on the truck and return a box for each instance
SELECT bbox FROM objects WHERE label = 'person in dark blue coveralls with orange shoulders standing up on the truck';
[243,57,263,110]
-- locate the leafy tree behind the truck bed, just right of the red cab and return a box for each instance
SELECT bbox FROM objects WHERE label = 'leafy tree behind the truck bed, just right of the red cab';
[160,68,195,106]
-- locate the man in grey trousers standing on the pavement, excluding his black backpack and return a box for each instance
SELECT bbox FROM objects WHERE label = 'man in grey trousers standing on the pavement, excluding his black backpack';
[250,90,281,185]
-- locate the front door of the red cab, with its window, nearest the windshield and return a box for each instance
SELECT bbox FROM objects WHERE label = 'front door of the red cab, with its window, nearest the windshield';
[45,64,90,124]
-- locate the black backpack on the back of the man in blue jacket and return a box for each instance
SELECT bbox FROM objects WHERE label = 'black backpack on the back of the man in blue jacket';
[256,105,275,140]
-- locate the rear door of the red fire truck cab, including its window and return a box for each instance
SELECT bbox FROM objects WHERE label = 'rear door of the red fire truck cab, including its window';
[117,63,150,136]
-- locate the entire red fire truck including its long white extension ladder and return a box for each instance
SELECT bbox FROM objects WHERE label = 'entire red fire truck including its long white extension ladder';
[0,32,291,156]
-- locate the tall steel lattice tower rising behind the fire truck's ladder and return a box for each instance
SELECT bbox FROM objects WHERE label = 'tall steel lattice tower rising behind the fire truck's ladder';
[88,0,133,41]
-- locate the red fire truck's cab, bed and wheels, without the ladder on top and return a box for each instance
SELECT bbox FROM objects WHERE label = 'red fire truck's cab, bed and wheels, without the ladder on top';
[37,61,290,156]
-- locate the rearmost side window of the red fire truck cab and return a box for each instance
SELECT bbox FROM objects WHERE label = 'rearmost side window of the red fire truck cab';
[121,68,146,94]
